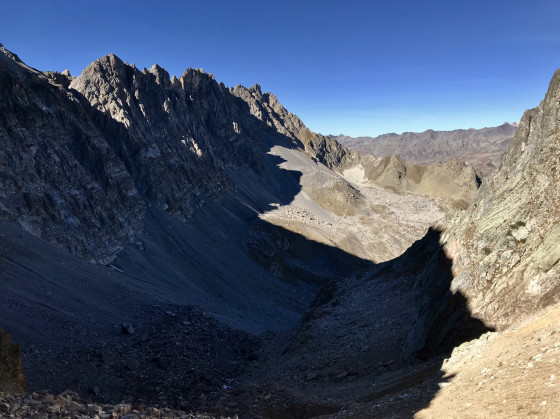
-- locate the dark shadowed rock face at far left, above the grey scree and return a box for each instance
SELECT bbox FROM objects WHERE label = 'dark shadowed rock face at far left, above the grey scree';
[0,48,144,262]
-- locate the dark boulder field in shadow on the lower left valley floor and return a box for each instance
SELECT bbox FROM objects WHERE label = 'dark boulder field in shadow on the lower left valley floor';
[19,306,259,411]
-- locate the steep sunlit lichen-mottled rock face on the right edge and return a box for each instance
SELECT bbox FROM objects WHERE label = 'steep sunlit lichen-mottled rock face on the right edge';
[409,71,560,354]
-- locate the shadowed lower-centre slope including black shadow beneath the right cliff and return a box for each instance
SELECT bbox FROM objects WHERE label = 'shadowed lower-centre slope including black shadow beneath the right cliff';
[236,229,493,418]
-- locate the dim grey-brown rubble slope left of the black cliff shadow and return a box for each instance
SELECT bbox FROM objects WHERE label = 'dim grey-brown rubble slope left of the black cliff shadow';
[218,232,456,418]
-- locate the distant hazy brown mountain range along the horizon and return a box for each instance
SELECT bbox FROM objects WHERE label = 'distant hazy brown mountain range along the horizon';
[334,122,519,176]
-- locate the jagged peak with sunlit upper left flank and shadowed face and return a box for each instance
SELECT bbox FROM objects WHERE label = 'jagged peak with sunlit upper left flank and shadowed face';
[70,55,237,223]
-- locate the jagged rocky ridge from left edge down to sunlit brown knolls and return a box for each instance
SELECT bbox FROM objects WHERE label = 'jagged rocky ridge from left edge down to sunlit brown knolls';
[0,43,482,263]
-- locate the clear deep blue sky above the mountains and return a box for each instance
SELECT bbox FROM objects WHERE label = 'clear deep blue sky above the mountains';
[0,0,560,136]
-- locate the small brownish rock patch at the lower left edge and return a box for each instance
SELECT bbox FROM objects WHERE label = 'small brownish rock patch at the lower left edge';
[0,329,26,394]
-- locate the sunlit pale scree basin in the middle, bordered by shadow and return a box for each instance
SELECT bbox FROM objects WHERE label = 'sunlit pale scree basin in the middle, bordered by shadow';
[260,147,446,263]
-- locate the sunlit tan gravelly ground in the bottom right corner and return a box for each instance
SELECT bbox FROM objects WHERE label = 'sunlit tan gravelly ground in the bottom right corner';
[418,306,560,419]
